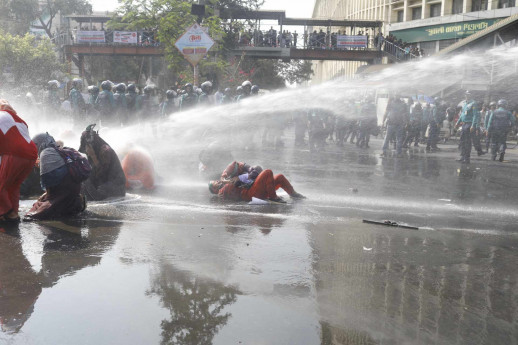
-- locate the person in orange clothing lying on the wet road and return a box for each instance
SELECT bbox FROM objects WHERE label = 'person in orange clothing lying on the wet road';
[209,169,305,203]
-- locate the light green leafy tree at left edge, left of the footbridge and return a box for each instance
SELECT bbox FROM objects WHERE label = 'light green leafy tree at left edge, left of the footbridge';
[0,32,63,84]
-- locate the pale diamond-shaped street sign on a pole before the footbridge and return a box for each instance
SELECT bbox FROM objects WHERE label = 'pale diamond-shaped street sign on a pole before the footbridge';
[175,24,214,66]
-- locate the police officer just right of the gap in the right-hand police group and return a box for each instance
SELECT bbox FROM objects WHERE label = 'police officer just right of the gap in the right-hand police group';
[382,96,409,157]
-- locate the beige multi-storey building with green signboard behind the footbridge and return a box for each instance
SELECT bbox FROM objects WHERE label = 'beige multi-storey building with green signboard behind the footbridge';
[313,0,518,83]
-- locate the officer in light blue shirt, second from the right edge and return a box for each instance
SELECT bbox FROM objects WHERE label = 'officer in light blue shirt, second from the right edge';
[455,91,480,163]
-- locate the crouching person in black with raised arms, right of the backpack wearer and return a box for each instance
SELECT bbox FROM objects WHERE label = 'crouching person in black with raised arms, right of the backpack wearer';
[79,125,126,201]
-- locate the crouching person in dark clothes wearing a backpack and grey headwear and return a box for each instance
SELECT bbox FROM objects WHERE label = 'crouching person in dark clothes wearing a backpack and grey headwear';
[25,133,86,220]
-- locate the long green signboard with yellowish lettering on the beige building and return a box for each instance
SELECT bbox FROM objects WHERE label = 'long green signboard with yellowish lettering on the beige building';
[390,18,501,43]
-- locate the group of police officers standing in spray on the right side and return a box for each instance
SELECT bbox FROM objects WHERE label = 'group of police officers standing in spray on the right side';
[293,91,516,163]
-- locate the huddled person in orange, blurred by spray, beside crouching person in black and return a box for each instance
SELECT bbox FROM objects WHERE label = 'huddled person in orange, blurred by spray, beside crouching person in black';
[122,149,155,190]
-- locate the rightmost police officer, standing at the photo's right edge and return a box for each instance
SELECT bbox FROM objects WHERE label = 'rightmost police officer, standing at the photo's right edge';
[487,99,515,162]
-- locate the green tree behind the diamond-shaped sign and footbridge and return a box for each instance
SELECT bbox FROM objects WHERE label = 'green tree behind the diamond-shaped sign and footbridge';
[109,0,263,85]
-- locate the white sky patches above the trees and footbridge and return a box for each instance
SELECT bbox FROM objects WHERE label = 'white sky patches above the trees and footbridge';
[90,0,315,18]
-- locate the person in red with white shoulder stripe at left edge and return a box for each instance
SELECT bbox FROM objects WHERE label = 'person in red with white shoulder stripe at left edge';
[0,99,38,223]
